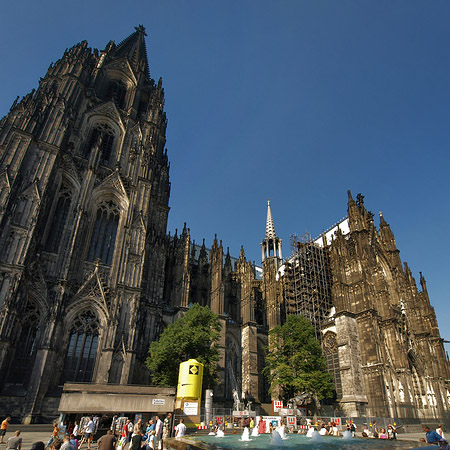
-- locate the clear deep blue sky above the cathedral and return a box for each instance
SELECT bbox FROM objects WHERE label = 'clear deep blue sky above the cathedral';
[0,0,450,348]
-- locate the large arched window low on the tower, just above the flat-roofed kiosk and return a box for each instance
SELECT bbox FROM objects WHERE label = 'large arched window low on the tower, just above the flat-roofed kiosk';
[61,310,100,384]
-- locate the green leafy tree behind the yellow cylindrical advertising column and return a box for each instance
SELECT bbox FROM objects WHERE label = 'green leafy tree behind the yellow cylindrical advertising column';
[146,304,221,388]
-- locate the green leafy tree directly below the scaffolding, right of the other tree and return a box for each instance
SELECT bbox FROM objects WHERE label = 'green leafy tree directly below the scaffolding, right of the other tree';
[263,315,334,401]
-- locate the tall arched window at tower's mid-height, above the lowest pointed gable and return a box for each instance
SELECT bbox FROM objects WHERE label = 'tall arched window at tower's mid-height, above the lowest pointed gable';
[88,201,120,265]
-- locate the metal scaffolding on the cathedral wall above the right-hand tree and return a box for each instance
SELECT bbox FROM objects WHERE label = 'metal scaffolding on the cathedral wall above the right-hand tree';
[283,234,332,340]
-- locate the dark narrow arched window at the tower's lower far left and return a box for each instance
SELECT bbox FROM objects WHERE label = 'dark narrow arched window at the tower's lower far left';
[8,302,40,385]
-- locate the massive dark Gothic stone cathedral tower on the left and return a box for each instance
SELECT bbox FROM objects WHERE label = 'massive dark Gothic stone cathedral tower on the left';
[0,26,170,422]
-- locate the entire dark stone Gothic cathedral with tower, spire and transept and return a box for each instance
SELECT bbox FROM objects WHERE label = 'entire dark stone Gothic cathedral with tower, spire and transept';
[0,26,450,423]
